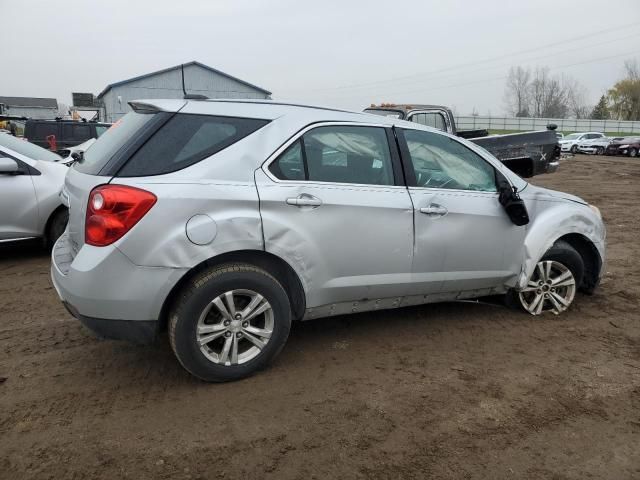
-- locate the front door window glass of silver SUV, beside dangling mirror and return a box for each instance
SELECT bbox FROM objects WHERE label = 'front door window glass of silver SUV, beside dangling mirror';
[403,130,496,192]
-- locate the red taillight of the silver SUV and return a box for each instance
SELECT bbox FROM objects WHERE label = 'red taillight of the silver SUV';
[84,185,157,247]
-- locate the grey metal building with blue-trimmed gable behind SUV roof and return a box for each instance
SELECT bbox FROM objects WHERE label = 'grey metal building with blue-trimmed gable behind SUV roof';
[97,61,271,122]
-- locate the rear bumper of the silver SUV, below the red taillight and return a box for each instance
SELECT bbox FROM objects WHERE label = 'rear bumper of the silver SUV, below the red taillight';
[51,234,186,343]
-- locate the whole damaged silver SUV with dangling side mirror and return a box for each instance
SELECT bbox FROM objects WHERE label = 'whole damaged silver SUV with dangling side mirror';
[52,100,605,381]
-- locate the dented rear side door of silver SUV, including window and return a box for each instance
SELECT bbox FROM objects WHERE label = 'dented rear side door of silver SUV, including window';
[256,123,413,314]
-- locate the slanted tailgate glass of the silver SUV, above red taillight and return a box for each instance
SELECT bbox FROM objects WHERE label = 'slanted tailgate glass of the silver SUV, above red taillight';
[73,112,155,175]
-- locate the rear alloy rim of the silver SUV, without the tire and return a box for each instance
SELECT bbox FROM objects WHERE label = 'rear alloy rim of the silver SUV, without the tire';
[196,290,274,365]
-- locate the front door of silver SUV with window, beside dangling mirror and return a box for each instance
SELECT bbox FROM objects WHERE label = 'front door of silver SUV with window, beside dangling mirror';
[397,129,525,294]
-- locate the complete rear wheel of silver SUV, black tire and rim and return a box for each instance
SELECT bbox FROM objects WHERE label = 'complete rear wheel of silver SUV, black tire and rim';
[169,264,291,382]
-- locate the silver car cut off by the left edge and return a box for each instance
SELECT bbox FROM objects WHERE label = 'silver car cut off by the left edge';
[0,133,68,246]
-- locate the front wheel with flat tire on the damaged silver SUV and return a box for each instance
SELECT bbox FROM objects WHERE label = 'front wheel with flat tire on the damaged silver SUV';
[510,240,584,315]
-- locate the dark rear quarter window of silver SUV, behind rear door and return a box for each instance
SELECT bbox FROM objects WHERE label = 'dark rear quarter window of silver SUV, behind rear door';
[117,113,268,177]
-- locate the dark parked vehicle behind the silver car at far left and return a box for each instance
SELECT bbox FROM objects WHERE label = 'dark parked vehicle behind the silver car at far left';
[24,119,111,151]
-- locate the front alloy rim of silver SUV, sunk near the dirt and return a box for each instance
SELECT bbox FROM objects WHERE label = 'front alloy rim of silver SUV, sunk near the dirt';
[518,260,576,315]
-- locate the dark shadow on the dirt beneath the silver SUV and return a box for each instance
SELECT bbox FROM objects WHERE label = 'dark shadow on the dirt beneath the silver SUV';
[62,302,532,392]
